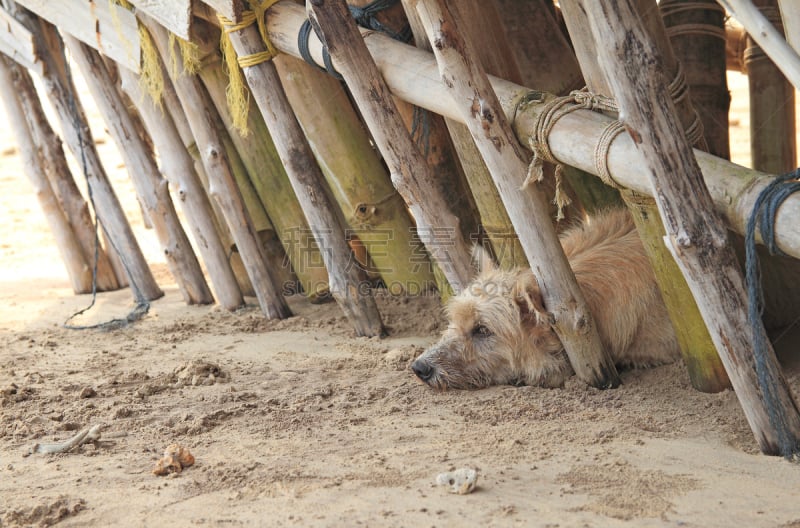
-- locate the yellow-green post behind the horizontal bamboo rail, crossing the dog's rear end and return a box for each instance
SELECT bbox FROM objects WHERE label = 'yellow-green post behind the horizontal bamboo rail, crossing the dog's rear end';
[561,0,730,392]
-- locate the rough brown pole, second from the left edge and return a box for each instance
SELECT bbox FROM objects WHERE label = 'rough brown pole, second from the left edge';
[0,53,122,293]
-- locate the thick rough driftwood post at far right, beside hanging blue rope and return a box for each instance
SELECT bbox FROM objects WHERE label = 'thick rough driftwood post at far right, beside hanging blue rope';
[585,0,800,456]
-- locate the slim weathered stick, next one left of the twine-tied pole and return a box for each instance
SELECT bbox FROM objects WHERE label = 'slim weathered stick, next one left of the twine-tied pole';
[140,16,291,319]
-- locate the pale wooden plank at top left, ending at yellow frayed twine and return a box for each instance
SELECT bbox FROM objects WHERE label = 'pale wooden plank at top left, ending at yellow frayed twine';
[12,0,141,73]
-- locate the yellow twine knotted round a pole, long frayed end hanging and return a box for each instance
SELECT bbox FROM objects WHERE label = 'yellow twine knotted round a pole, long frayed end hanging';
[218,0,278,136]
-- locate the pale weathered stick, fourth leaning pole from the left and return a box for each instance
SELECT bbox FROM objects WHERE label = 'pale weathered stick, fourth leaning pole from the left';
[64,35,214,304]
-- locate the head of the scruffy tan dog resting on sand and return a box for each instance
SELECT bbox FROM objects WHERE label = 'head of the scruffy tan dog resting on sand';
[411,245,569,390]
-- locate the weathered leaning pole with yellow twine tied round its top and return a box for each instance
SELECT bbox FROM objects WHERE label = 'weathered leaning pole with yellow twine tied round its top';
[222,13,384,337]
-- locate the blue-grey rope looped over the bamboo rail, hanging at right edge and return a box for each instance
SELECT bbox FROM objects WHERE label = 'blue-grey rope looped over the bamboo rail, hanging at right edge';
[745,169,800,459]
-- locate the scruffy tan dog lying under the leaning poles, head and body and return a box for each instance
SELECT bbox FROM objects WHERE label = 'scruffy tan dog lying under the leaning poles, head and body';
[411,209,679,390]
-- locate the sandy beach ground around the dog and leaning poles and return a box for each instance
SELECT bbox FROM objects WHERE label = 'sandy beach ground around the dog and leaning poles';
[0,68,800,528]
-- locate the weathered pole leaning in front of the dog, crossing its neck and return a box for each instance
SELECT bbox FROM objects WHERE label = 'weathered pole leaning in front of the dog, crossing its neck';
[410,0,619,388]
